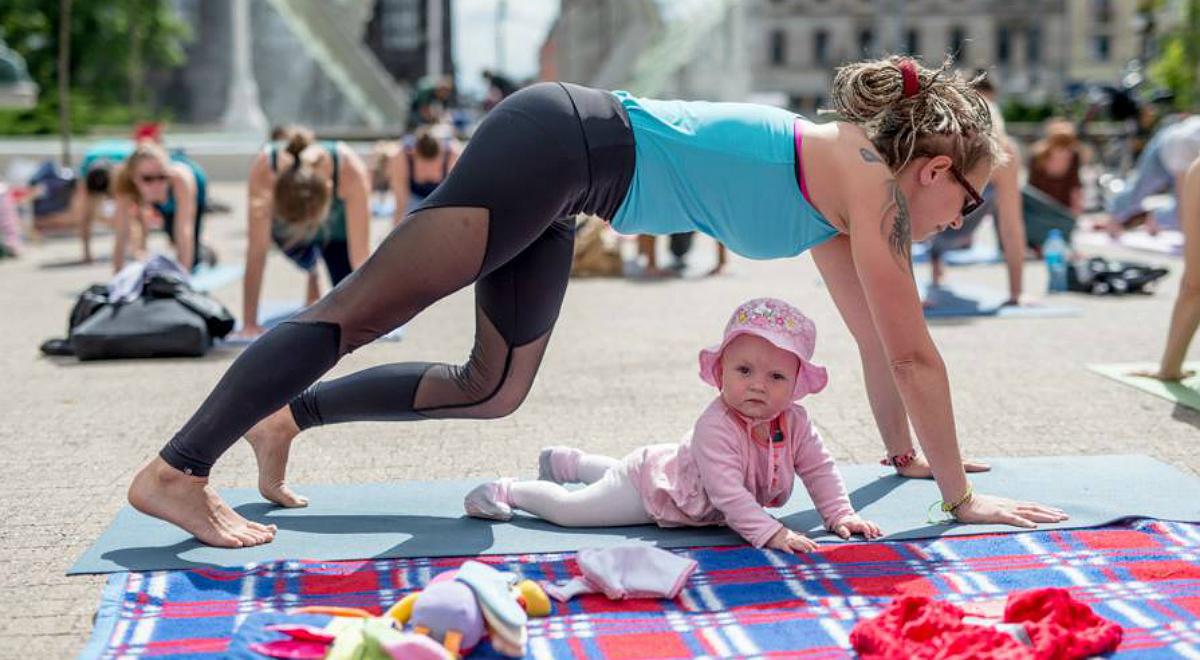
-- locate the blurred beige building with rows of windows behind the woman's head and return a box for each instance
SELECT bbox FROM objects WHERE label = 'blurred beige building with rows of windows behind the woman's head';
[749,0,1139,113]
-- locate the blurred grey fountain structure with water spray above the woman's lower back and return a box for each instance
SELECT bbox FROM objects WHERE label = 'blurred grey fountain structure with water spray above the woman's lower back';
[541,0,751,101]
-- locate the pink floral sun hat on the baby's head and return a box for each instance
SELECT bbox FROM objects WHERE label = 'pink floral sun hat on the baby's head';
[700,298,829,401]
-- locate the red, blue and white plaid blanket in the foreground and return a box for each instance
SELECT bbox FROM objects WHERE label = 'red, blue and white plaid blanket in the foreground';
[84,520,1200,659]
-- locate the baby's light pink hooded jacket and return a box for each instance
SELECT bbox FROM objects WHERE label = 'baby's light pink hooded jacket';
[625,398,854,547]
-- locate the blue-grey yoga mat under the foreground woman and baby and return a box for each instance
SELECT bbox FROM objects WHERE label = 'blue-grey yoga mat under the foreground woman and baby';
[67,456,1200,575]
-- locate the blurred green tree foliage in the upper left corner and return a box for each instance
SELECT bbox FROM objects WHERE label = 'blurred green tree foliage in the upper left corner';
[0,0,191,133]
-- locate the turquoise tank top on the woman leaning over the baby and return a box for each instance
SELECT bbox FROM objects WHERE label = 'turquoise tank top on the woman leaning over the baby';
[612,91,838,259]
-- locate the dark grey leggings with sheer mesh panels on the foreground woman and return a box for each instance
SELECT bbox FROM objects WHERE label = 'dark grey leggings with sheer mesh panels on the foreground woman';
[160,83,635,475]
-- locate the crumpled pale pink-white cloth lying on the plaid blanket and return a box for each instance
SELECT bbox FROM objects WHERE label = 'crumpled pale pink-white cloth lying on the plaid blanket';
[542,546,698,602]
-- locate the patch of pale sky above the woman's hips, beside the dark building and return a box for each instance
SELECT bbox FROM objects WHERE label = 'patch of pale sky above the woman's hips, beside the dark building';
[451,0,559,95]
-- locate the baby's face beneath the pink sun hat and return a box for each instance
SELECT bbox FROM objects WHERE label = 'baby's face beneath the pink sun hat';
[721,335,800,421]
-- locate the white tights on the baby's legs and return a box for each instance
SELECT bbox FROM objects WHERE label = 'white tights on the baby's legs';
[509,454,654,527]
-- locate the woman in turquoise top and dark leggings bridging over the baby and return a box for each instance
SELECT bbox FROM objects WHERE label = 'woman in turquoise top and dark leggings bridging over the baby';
[130,60,1061,547]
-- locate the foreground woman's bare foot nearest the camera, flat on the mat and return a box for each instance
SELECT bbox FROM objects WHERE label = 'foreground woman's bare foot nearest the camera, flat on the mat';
[128,456,275,547]
